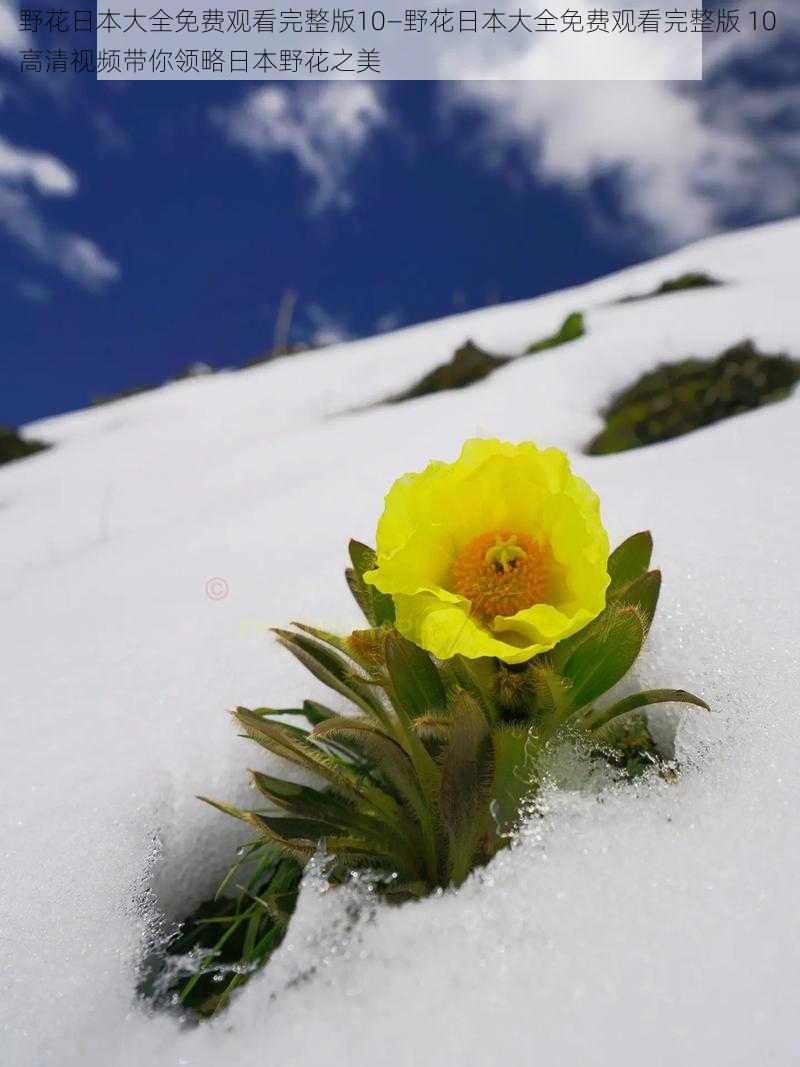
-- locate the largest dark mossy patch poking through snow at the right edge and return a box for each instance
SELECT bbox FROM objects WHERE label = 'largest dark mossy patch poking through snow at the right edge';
[587,340,800,456]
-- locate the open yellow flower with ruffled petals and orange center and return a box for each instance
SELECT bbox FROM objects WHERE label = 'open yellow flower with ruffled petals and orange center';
[364,440,608,664]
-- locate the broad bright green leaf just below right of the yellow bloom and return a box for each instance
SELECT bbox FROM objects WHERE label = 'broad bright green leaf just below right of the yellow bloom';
[563,605,645,710]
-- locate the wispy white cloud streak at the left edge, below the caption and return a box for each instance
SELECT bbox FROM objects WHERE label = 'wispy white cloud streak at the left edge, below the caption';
[0,138,122,289]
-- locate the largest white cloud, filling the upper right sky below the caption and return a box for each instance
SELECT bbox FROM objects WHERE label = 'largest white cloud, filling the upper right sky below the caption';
[443,16,800,246]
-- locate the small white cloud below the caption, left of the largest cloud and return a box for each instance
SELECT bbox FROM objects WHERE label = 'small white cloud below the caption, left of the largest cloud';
[211,82,387,211]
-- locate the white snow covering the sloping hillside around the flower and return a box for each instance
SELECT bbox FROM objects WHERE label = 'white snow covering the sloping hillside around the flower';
[0,220,800,1067]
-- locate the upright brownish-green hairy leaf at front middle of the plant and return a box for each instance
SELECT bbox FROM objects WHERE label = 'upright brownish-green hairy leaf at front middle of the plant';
[438,692,494,886]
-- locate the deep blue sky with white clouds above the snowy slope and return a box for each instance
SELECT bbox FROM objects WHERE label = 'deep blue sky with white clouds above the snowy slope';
[0,0,800,425]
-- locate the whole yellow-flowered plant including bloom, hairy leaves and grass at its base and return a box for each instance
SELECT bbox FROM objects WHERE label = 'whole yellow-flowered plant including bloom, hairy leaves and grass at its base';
[144,439,707,1014]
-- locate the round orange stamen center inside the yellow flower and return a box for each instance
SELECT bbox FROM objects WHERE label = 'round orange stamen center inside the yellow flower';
[451,531,553,621]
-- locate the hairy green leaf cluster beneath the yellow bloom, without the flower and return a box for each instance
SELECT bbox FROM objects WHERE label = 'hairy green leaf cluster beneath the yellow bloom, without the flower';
[196,534,707,926]
